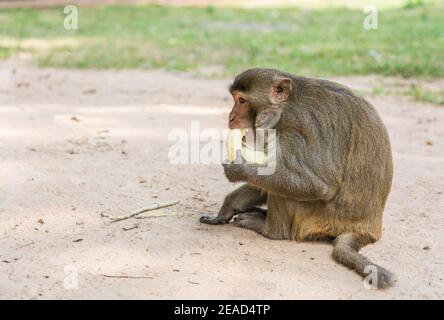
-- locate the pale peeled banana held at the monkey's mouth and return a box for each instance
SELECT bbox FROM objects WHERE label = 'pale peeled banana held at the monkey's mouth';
[227,129,267,164]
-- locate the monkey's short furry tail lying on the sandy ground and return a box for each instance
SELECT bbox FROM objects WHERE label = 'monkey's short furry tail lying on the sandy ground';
[333,233,395,289]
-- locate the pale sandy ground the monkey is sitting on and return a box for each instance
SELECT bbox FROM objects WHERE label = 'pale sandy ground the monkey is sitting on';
[0,63,444,299]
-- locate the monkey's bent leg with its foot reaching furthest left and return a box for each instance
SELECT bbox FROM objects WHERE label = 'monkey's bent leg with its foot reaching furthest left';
[200,184,267,224]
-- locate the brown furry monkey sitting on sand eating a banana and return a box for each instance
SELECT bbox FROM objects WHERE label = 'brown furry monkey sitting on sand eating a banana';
[200,68,394,288]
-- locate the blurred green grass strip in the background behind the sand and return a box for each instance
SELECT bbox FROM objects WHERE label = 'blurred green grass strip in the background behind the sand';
[0,1,444,78]
